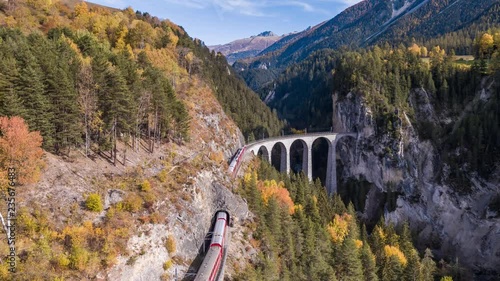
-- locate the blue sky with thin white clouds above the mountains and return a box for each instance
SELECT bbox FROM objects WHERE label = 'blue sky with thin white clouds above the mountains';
[89,0,360,45]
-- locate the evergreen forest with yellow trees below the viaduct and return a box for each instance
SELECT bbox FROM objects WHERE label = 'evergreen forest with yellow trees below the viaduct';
[235,160,468,281]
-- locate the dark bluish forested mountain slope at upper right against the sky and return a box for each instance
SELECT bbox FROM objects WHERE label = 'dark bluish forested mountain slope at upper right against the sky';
[237,0,500,89]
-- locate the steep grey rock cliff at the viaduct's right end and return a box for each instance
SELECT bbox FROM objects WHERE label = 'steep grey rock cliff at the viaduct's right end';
[333,89,500,280]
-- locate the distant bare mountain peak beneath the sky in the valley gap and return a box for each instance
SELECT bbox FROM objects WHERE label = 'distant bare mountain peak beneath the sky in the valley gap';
[208,31,285,65]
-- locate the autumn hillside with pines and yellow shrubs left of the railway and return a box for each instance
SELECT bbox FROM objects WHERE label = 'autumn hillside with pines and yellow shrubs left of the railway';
[0,0,282,280]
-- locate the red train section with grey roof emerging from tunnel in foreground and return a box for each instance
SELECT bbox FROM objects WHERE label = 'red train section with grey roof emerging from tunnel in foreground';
[194,210,230,281]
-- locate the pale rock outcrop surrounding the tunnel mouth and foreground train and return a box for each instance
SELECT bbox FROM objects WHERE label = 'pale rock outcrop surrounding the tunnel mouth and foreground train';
[107,167,249,281]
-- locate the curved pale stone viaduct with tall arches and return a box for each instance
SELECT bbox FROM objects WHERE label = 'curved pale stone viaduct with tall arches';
[245,132,357,195]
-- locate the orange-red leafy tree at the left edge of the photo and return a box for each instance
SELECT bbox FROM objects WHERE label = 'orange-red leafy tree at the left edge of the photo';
[0,116,43,183]
